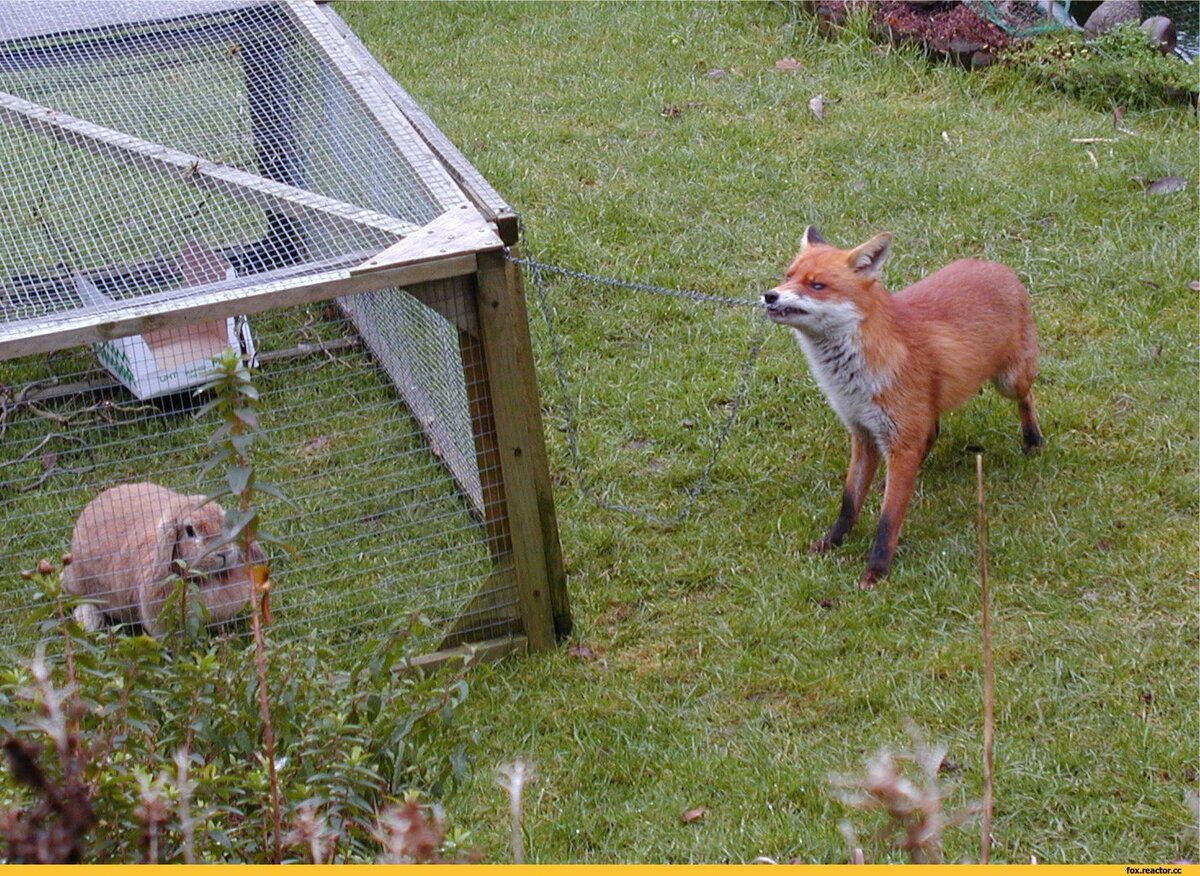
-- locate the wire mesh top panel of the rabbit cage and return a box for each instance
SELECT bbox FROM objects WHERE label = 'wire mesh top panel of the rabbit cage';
[0,0,466,338]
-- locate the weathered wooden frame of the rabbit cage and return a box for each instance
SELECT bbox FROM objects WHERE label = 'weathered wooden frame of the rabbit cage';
[0,0,571,666]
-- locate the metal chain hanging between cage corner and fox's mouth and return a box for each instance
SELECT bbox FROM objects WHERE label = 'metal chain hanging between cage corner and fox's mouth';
[508,254,767,529]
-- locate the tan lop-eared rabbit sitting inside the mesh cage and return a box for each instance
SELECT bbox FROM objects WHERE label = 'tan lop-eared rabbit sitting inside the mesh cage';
[62,484,266,636]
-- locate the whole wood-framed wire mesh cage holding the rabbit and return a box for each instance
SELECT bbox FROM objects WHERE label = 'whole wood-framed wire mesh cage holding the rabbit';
[0,0,568,650]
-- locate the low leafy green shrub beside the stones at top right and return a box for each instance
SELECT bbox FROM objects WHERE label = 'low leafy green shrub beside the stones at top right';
[1001,24,1200,109]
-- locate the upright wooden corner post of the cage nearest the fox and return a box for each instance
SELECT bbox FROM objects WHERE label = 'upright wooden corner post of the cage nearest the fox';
[475,251,571,649]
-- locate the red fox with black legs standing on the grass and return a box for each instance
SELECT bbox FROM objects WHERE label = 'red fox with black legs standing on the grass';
[762,226,1043,589]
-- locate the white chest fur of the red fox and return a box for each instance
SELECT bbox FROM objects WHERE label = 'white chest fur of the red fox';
[792,325,895,452]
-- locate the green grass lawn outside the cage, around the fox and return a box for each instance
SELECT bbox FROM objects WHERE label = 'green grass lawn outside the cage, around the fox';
[340,4,1200,863]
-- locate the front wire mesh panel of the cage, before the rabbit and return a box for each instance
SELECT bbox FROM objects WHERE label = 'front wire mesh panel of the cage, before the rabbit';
[0,284,516,650]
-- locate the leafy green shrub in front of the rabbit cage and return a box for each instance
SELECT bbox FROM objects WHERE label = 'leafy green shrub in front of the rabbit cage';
[0,576,468,863]
